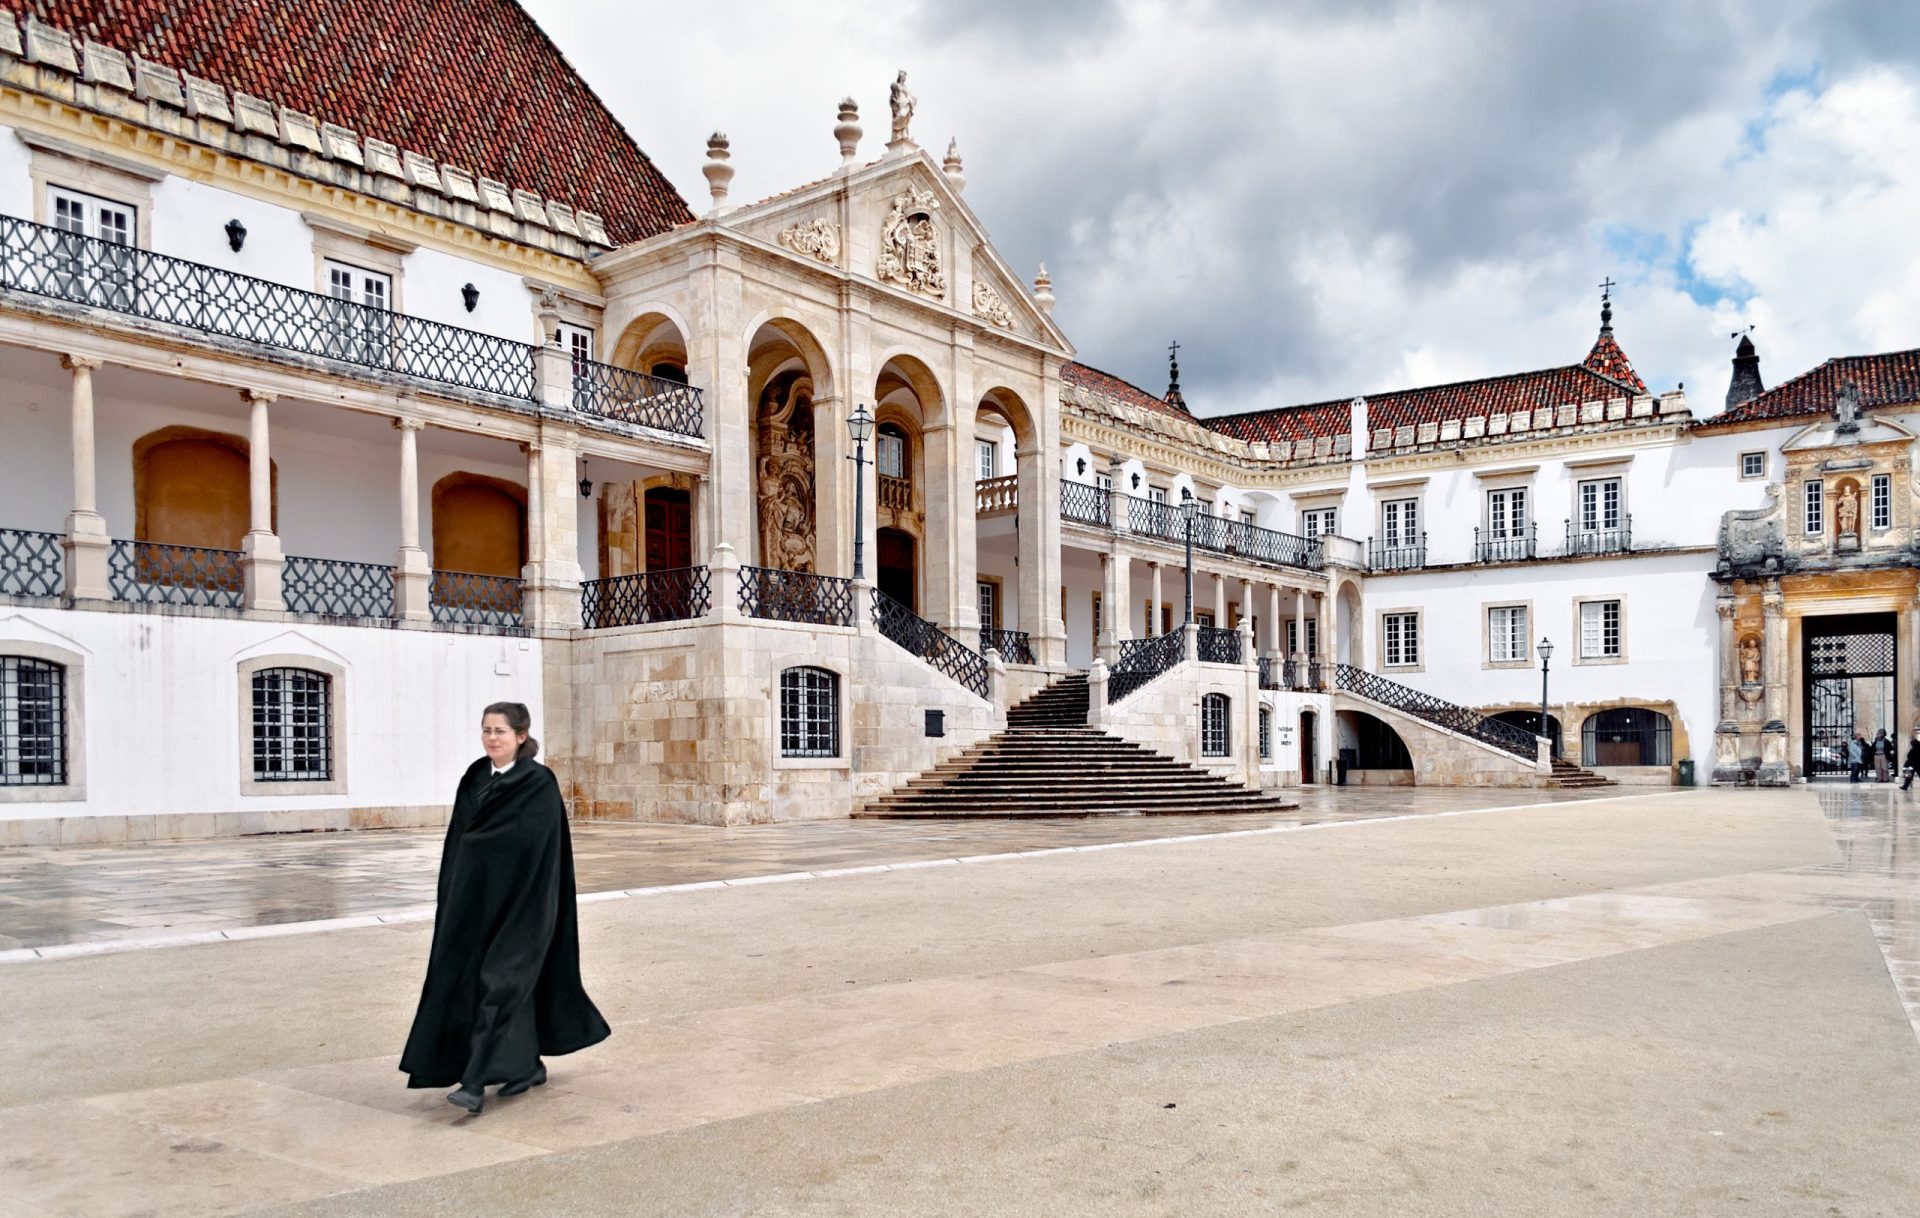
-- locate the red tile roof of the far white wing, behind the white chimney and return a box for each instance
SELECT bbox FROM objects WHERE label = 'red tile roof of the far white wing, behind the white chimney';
[1200,363,1632,442]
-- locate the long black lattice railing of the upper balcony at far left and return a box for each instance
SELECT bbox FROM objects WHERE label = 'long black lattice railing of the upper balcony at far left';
[0,215,534,402]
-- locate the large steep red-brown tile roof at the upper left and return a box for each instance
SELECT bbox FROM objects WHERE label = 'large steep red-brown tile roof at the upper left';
[0,0,693,244]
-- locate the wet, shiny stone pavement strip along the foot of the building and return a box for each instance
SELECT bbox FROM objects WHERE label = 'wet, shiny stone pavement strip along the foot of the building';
[0,786,1620,959]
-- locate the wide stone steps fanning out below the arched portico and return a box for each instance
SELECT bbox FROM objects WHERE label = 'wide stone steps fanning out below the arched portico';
[854,672,1298,818]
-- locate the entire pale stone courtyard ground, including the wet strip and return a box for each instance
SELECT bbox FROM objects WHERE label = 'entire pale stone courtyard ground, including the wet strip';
[0,788,1920,1218]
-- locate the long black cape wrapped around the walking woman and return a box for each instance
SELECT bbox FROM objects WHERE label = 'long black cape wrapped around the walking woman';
[399,757,609,1087]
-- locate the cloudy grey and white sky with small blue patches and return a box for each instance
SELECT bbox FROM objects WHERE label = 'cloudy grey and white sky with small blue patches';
[526,0,1920,415]
